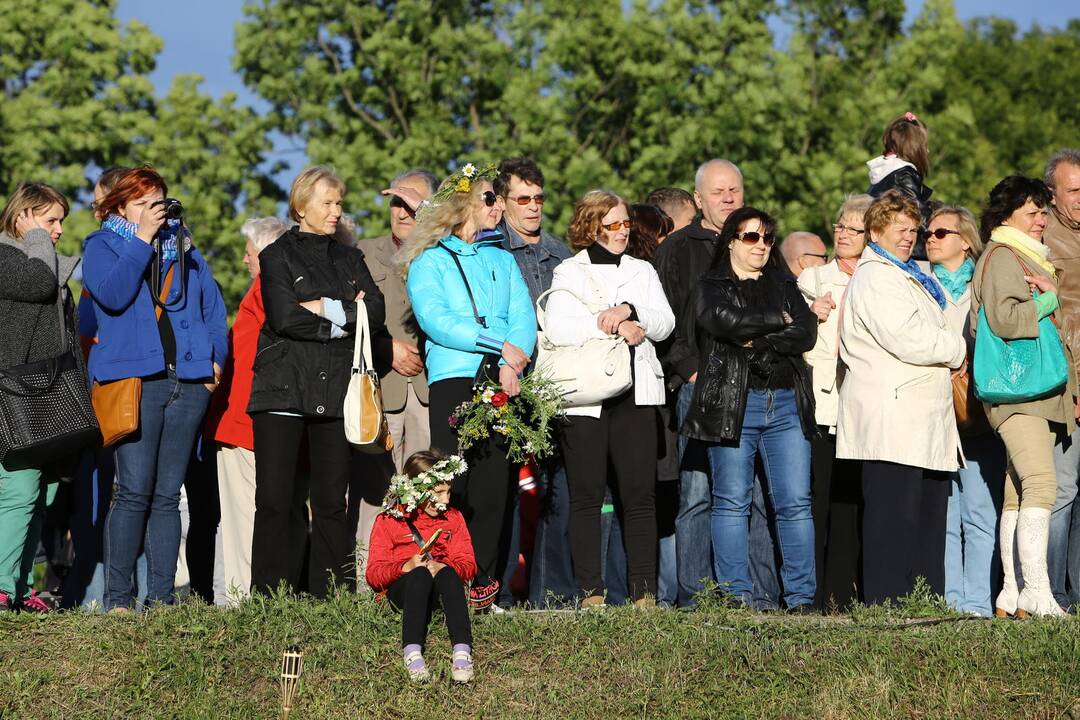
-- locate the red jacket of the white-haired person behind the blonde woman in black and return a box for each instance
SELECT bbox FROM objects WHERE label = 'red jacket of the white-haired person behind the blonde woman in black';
[206,276,266,450]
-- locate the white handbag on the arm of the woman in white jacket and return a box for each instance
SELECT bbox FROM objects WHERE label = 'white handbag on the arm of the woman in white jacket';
[536,287,634,407]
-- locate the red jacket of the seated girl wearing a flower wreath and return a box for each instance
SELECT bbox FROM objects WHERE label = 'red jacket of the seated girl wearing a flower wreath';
[367,507,476,593]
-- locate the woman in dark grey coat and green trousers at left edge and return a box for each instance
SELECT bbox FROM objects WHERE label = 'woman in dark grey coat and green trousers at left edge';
[0,182,78,612]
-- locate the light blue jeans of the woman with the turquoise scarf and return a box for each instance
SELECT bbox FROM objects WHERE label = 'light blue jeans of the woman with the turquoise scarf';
[945,433,1005,617]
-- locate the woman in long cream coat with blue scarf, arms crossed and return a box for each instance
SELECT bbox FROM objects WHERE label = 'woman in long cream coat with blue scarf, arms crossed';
[836,191,967,603]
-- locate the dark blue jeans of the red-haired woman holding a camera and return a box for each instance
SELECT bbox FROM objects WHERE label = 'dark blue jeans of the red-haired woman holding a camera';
[105,370,211,610]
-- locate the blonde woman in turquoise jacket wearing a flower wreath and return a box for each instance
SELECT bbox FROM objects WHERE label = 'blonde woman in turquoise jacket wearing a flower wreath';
[401,164,537,608]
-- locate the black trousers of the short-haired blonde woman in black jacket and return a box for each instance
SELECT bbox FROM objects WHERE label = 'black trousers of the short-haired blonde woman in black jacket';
[252,412,355,598]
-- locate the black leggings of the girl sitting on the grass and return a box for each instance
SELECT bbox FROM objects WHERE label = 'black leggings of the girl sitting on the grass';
[387,566,472,648]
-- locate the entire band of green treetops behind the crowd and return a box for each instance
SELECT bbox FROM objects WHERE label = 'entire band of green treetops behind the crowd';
[0,0,1080,305]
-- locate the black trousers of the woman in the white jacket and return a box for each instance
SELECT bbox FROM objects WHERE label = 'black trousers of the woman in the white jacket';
[563,390,657,600]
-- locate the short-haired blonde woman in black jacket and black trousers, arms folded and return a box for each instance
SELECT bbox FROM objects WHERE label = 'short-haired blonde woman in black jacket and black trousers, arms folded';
[247,167,389,598]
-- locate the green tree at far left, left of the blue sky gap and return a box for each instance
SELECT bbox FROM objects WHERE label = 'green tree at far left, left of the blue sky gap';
[0,0,282,307]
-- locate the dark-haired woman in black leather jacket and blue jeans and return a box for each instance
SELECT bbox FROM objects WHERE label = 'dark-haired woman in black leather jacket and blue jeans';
[683,207,818,612]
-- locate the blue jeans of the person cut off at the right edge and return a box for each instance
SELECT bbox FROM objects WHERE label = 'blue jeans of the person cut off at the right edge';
[1047,430,1080,608]
